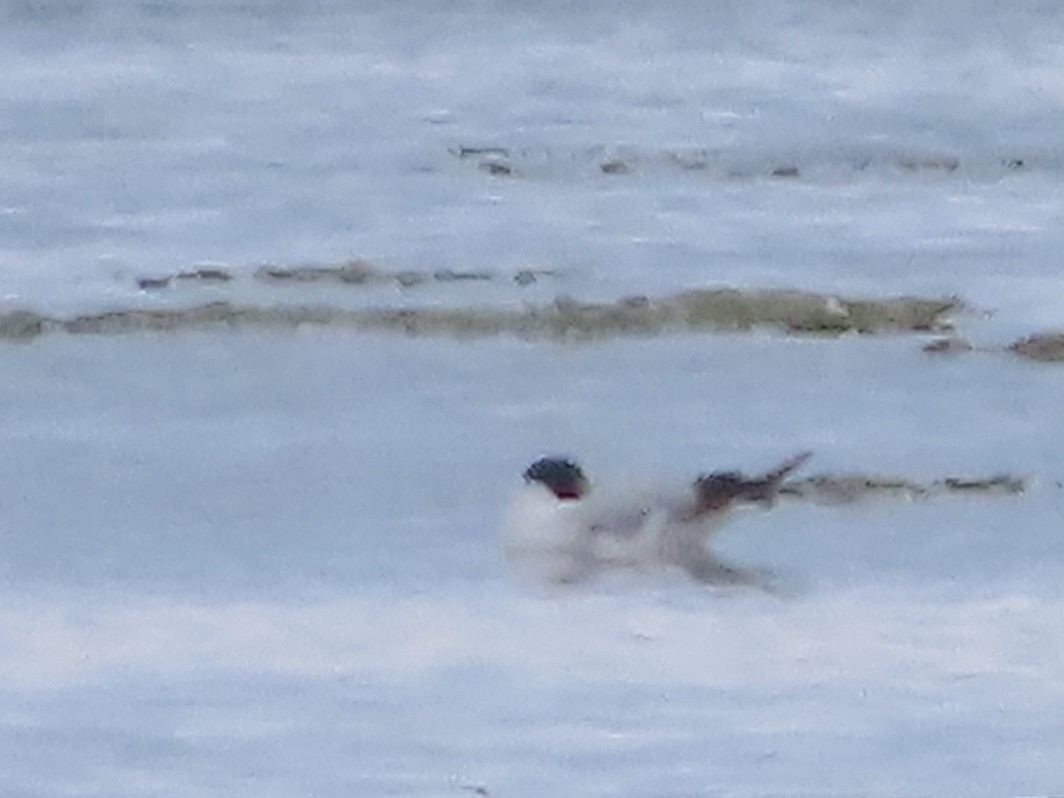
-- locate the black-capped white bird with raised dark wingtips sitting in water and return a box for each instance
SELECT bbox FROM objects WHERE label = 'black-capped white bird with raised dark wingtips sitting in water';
[503,451,812,586]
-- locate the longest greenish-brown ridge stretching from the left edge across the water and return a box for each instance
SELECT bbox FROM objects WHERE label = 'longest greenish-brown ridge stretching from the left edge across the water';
[0,288,962,340]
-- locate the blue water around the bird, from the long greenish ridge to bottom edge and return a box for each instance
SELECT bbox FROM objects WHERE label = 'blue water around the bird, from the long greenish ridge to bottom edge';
[0,334,1064,796]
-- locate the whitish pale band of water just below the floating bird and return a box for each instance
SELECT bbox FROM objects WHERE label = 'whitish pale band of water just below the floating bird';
[0,583,1064,689]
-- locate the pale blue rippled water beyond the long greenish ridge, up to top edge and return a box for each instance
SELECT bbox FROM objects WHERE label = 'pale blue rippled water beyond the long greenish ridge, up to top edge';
[0,2,1064,321]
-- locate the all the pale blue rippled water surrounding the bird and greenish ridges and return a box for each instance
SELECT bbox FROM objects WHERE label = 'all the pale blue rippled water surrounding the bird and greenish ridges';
[0,0,1064,798]
